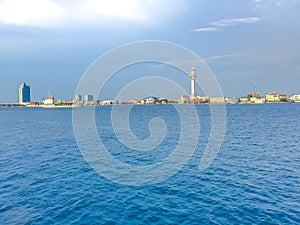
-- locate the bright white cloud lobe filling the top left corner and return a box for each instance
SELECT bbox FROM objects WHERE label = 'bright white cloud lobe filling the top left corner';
[0,0,64,26]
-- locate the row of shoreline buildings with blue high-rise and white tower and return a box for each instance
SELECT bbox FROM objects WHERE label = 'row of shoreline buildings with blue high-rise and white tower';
[5,79,300,107]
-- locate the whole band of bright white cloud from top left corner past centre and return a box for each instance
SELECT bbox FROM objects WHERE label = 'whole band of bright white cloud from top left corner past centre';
[0,0,185,26]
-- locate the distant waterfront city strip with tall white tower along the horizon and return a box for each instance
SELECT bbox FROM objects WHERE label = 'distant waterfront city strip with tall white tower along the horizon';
[0,68,300,108]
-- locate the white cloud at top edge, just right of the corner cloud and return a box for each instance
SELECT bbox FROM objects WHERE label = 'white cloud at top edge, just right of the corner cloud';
[72,0,185,23]
